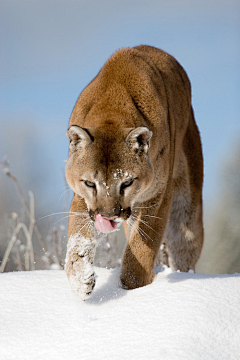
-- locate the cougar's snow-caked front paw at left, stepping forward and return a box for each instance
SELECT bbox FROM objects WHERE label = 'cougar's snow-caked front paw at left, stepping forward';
[65,235,96,300]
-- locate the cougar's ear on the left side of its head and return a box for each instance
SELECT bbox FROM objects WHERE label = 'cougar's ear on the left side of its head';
[66,125,94,153]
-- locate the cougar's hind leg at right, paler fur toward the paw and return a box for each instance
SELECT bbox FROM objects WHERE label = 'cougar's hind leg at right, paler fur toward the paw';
[166,110,203,271]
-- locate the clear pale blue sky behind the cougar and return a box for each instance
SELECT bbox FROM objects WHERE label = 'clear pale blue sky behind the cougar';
[0,0,240,217]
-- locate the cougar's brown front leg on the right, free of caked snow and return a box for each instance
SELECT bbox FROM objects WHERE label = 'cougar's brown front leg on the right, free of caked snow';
[121,191,171,289]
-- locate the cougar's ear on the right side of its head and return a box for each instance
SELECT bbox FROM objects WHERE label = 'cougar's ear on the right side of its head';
[126,126,152,153]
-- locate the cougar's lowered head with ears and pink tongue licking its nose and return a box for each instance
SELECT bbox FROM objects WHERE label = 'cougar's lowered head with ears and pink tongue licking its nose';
[66,125,153,233]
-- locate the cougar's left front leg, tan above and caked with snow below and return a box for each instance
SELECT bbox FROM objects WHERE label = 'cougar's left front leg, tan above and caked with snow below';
[65,195,96,300]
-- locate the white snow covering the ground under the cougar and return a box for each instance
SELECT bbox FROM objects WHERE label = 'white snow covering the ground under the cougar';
[0,267,240,360]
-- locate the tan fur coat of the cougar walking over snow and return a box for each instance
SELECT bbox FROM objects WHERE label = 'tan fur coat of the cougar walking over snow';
[66,46,203,298]
